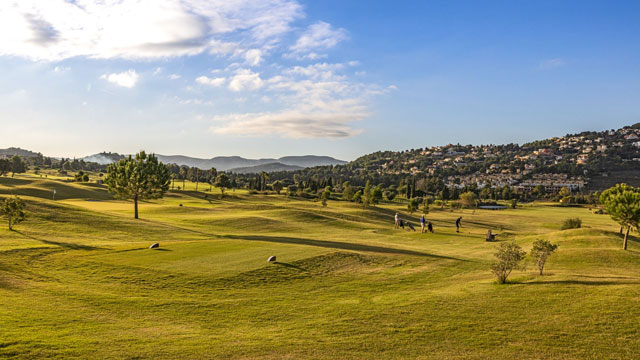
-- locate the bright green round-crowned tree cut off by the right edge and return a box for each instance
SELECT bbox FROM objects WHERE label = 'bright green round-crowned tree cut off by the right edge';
[600,184,640,250]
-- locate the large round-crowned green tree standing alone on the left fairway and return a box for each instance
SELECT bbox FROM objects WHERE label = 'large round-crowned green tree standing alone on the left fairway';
[105,151,171,219]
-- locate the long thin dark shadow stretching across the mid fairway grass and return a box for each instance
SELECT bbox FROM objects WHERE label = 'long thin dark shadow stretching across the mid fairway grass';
[222,235,467,261]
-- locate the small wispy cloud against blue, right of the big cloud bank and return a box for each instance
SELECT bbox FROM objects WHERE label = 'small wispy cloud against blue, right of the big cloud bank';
[289,21,347,59]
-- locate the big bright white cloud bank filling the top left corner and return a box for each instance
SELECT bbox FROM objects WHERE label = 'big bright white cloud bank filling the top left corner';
[0,0,303,60]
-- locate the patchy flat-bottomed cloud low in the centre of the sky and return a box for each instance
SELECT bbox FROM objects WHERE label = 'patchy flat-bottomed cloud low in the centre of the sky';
[211,63,386,138]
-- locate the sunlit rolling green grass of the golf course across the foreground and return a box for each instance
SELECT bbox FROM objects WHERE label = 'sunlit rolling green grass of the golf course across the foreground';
[0,174,640,359]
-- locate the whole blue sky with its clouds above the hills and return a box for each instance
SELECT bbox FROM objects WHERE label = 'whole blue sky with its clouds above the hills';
[0,0,640,160]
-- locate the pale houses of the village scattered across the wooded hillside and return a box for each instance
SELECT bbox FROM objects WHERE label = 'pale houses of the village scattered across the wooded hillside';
[342,124,640,192]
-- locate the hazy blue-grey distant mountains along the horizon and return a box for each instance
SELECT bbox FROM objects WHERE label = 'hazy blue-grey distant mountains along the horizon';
[76,152,347,174]
